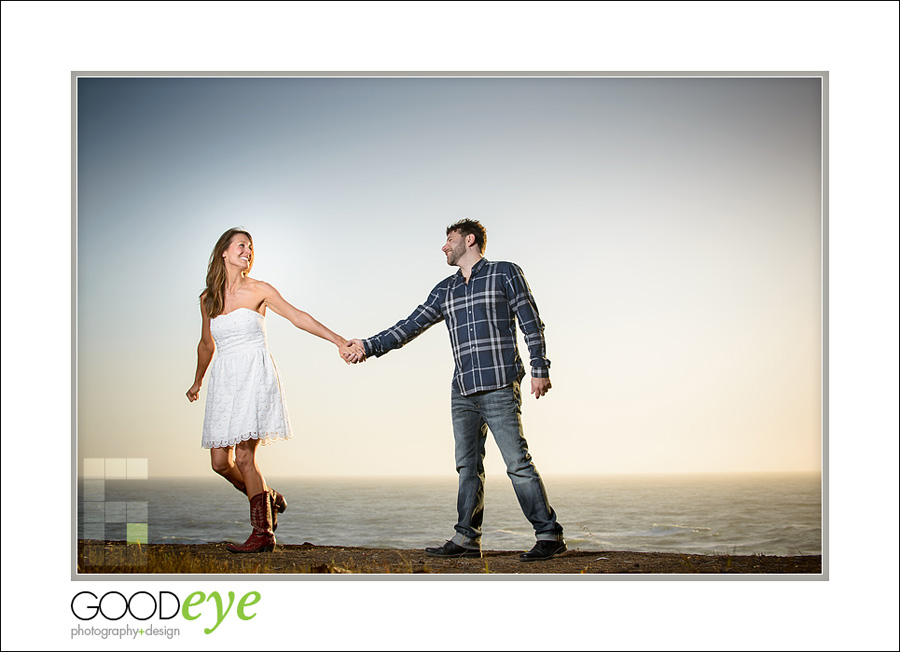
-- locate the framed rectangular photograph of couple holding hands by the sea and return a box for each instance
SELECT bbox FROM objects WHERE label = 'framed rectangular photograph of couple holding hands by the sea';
[73,73,827,579]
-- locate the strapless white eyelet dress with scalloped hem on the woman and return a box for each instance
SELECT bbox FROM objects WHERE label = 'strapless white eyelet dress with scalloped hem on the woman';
[202,308,292,448]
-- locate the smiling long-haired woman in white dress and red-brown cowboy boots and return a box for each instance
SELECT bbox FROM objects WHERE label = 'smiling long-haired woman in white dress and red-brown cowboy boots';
[187,229,364,552]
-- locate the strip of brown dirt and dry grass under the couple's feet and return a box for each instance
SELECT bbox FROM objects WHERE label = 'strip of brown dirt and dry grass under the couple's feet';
[78,541,822,575]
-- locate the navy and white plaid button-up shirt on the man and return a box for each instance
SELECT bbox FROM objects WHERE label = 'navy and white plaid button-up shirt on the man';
[364,258,550,396]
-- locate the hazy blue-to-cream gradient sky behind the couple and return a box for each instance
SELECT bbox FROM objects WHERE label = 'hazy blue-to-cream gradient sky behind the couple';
[76,75,823,477]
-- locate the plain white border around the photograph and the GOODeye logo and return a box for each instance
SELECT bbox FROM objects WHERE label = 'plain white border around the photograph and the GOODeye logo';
[0,2,898,650]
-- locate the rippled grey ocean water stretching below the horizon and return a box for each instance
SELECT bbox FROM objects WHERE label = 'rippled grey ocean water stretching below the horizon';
[78,473,822,556]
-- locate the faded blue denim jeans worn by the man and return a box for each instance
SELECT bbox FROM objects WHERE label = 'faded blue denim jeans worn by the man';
[450,383,563,548]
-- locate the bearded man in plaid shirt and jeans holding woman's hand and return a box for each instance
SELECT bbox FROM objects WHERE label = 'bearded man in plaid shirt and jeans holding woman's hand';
[353,220,566,561]
